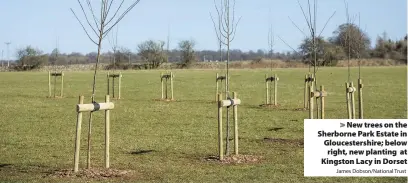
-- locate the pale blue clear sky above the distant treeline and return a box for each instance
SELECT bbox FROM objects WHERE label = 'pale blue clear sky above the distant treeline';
[0,0,407,59]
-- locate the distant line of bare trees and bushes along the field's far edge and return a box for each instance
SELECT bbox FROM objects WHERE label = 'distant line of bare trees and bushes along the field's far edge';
[3,24,407,70]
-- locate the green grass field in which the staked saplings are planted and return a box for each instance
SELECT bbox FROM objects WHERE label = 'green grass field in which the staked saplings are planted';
[0,67,407,183]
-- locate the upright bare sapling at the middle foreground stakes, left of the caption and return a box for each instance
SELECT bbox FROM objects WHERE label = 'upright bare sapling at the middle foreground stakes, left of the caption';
[210,0,241,156]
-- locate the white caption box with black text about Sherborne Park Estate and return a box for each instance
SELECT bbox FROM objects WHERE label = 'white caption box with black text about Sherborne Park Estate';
[304,119,408,177]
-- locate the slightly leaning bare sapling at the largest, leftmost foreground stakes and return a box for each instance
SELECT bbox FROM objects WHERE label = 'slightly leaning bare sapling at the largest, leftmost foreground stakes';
[70,0,140,169]
